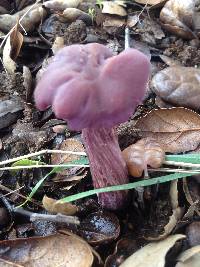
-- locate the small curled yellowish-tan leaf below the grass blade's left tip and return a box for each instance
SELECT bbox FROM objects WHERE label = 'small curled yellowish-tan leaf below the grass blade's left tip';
[42,196,78,215]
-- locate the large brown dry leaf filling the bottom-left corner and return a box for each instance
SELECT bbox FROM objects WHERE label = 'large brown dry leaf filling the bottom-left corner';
[0,234,93,267]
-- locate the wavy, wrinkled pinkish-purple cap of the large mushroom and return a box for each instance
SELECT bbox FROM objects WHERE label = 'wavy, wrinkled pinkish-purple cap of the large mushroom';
[35,44,150,130]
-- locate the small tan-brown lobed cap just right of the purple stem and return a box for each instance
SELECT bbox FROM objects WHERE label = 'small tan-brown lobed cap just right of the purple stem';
[122,138,165,177]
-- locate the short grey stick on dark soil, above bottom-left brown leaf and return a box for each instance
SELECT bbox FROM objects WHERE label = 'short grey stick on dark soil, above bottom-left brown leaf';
[13,208,80,225]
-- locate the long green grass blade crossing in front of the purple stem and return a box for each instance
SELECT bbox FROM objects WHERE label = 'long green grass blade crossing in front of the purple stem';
[60,172,199,203]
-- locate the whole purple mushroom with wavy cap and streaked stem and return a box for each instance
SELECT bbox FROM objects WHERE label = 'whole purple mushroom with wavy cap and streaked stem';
[35,44,150,209]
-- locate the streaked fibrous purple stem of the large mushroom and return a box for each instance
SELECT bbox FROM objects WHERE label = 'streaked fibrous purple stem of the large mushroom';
[82,127,128,210]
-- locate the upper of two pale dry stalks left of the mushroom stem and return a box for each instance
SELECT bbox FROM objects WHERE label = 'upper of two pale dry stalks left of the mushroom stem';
[0,149,86,168]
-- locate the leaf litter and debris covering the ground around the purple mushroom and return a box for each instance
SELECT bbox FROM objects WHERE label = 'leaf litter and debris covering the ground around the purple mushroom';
[0,0,200,267]
